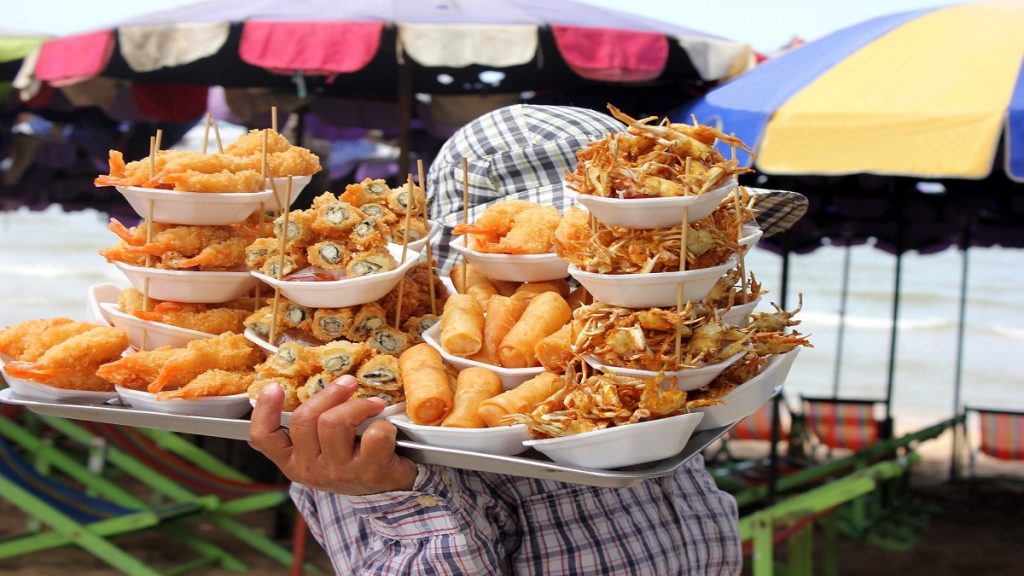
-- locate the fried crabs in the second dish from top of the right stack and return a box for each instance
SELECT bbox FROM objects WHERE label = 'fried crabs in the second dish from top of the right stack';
[554,207,740,274]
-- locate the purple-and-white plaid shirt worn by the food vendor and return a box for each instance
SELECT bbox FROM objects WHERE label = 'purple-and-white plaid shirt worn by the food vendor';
[292,456,742,576]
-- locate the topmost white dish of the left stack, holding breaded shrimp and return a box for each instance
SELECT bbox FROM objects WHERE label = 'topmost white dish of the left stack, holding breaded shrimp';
[118,186,273,225]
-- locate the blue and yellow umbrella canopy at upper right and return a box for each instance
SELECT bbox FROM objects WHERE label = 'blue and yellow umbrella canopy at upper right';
[678,1,1024,181]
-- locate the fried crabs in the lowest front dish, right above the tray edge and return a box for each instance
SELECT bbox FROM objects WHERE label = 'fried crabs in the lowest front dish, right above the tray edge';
[508,360,686,438]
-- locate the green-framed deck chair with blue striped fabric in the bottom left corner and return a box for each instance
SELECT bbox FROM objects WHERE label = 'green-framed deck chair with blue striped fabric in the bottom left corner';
[0,432,233,576]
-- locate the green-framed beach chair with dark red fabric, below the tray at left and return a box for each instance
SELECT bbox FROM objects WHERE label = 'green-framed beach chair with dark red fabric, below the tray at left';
[29,416,319,572]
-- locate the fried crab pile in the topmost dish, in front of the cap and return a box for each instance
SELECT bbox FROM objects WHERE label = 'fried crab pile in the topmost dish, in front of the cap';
[566,105,753,198]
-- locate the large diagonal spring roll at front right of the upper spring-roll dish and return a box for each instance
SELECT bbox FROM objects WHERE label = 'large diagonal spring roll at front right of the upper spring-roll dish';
[498,292,572,368]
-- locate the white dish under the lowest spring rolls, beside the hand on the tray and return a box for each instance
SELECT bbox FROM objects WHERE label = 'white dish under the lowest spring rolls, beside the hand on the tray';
[388,414,529,456]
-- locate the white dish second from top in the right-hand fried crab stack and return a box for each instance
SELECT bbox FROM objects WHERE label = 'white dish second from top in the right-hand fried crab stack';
[568,258,736,308]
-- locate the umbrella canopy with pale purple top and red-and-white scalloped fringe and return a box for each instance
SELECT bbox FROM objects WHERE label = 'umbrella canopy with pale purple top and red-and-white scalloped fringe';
[29,0,753,93]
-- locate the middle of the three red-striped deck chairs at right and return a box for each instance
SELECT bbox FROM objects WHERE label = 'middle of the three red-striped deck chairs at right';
[801,396,883,457]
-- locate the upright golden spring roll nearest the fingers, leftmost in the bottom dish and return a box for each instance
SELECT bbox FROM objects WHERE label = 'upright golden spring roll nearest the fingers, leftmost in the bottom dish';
[398,343,453,425]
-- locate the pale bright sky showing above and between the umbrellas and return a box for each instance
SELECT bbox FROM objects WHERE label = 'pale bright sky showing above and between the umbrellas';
[8,0,958,53]
